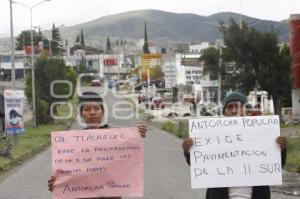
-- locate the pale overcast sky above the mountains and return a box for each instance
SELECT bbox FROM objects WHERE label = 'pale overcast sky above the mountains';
[0,0,300,37]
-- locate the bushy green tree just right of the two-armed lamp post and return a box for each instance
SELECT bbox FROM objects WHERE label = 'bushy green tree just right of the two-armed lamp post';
[25,57,76,123]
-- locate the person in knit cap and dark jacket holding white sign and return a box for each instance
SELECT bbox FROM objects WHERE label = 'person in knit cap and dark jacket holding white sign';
[182,91,287,199]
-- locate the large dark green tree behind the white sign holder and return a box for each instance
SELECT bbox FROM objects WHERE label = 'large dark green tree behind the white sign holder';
[223,20,291,114]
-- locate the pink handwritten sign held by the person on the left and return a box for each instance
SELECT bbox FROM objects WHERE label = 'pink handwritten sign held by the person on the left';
[51,128,144,199]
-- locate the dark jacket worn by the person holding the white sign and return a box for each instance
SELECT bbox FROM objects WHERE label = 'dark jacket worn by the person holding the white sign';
[184,149,286,199]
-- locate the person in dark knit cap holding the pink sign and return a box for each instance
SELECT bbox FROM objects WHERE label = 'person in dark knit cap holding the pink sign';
[48,92,147,199]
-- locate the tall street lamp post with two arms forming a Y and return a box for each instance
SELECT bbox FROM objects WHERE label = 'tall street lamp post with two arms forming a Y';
[11,0,51,128]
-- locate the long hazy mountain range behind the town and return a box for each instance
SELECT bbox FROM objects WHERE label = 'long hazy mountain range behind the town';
[0,9,289,48]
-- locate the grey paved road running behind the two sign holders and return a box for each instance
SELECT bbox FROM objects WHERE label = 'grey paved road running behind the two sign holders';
[0,88,205,199]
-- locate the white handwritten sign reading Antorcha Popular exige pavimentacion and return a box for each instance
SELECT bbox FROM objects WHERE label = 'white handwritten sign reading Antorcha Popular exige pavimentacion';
[189,116,282,188]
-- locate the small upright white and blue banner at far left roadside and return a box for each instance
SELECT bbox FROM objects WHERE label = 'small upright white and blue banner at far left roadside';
[4,90,24,134]
